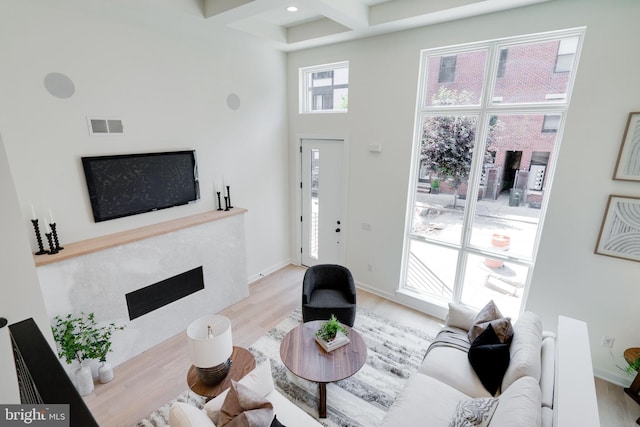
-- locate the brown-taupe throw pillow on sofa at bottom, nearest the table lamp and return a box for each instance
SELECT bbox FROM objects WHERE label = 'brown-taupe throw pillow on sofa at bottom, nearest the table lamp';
[217,380,273,427]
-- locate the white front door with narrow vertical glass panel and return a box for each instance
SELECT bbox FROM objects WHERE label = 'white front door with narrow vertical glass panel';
[300,139,345,266]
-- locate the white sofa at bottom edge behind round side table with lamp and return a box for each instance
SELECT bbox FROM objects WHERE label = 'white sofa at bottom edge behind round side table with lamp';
[169,359,322,427]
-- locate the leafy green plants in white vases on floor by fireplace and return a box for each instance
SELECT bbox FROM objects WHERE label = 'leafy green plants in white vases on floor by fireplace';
[51,313,124,395]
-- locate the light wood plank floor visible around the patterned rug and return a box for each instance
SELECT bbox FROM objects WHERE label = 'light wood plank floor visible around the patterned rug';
[85,265,640,427]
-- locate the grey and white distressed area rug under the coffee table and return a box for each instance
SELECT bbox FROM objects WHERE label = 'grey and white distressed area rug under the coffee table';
[138,309,433,427]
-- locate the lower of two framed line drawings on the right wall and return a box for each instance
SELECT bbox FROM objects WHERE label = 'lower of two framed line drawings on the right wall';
[595,195,640,261]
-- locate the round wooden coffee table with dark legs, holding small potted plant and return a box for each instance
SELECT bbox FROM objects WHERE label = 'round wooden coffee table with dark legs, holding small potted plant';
[280,320,367,418]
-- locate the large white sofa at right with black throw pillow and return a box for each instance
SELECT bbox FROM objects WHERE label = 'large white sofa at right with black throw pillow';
[383,304,600,427]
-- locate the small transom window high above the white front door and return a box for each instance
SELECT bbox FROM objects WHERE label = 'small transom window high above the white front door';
[300,62,349,113]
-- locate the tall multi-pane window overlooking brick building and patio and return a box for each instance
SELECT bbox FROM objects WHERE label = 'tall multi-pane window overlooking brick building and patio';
[399,29,584,318]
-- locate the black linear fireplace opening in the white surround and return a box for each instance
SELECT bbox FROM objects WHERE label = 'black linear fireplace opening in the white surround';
[126,266,204,320]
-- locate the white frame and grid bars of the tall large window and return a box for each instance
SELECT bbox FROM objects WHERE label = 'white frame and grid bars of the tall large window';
[397,28,586,318]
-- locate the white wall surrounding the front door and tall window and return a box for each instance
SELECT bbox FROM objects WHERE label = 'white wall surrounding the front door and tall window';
[288,0,640,383]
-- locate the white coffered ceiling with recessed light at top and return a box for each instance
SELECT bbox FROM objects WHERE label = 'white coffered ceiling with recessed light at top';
[204,0,550,51]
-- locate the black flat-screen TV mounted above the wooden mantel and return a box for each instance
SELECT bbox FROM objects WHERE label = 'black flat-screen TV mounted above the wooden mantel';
[82,150,200,222]
